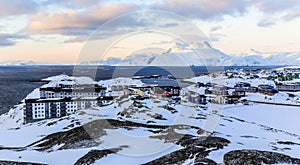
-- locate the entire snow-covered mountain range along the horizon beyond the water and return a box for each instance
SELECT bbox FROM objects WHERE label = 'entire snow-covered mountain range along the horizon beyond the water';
[0,41,300,66]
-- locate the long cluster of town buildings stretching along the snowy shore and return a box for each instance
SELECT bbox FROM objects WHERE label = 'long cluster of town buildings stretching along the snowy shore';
[24,68,300,122]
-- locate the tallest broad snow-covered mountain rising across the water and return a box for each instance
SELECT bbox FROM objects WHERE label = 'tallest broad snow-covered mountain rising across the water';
[119,43,230,66]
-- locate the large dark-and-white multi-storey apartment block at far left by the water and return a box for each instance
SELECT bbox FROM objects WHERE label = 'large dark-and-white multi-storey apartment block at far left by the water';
[24,75,113,122]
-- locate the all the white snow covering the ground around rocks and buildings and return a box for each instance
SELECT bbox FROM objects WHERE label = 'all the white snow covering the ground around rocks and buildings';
[0,75,300,164]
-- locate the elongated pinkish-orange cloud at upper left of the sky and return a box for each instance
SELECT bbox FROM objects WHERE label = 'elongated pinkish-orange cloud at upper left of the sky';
[25,3,135,34]
